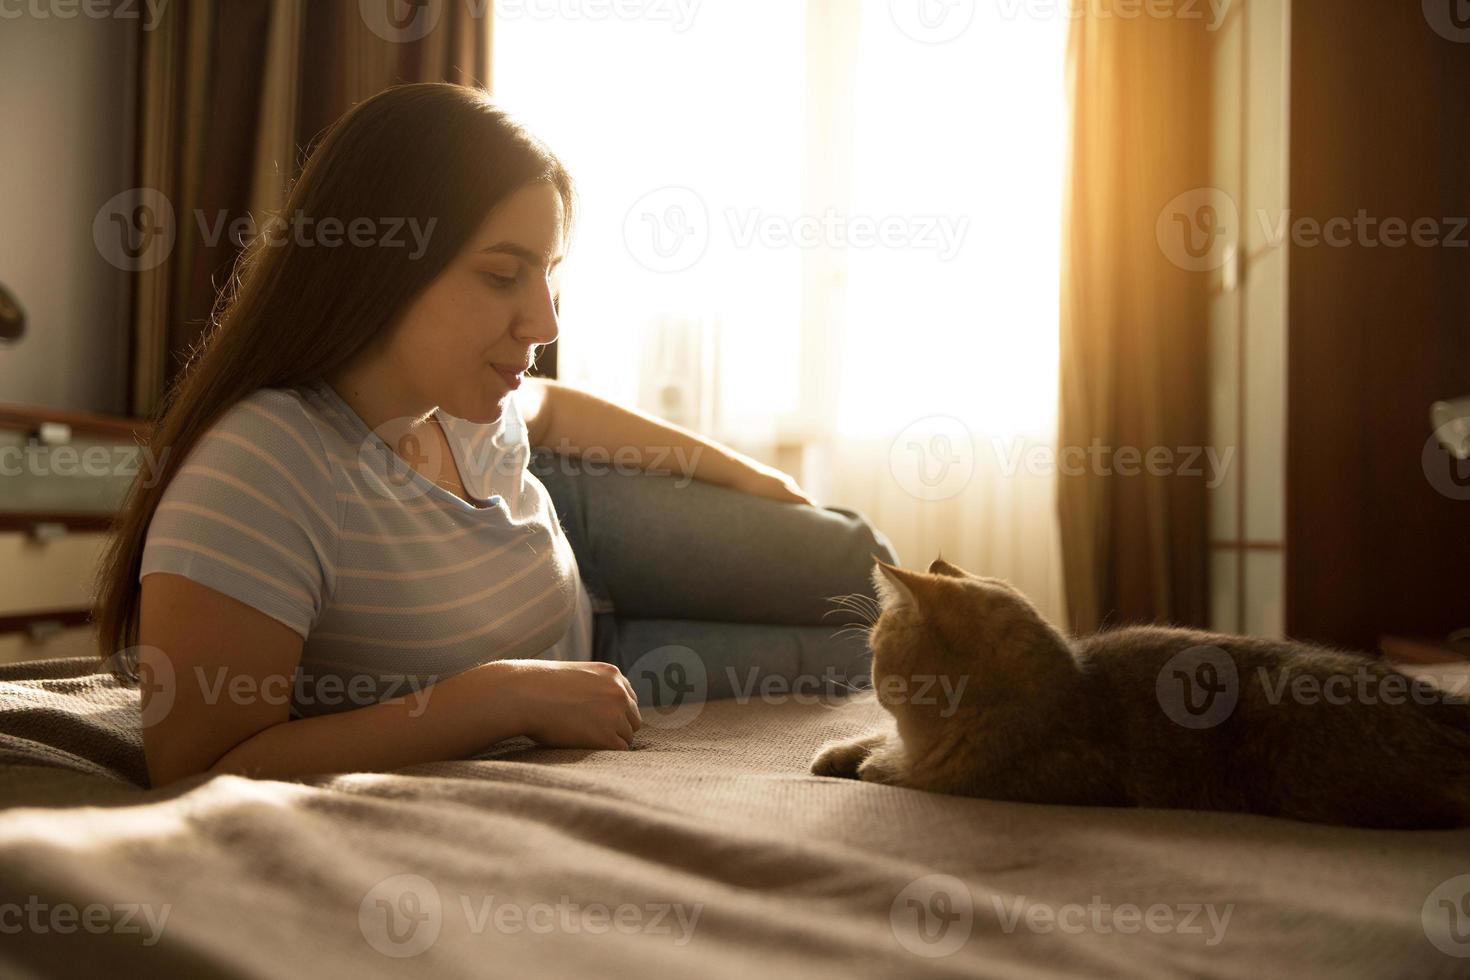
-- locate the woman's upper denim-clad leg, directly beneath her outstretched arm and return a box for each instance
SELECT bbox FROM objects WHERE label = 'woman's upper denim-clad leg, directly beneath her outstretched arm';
[531,451,898,626]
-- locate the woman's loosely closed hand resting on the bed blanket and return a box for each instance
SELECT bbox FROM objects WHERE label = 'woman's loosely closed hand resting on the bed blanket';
[500,660,642,749]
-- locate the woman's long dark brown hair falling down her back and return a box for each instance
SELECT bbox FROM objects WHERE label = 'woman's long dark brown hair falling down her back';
[93,82,573,670]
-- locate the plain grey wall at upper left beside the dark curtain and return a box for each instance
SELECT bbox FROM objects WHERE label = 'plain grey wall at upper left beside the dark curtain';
[0,13,138,413]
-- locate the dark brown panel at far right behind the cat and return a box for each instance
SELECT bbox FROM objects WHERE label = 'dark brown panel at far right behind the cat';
[1285,0,1470,651]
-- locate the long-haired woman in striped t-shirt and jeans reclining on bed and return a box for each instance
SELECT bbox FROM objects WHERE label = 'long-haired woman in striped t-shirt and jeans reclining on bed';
[97,84,895,785]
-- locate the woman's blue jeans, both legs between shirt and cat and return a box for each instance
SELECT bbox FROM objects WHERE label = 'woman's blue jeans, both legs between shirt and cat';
[529,451,898,705]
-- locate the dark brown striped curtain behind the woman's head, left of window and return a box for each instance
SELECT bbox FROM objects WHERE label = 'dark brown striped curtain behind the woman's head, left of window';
[131,0,491,416]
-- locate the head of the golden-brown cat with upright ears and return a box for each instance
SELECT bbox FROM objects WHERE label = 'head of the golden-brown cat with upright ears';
[872,558,1076,721]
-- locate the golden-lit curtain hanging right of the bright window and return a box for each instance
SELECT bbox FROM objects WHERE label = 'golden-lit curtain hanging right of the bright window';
[1058,0,1211,633]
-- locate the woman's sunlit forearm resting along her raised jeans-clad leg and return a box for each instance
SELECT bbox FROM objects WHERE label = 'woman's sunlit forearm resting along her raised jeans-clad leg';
[522,378,816,507]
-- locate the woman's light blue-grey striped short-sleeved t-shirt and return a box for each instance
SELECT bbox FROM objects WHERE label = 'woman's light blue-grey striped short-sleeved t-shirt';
[140,381,592,716]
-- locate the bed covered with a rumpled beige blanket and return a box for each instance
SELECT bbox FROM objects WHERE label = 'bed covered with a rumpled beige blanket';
[0,660,1470,980]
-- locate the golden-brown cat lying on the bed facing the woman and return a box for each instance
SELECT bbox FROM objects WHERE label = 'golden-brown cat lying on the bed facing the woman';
[811,558,1470,829]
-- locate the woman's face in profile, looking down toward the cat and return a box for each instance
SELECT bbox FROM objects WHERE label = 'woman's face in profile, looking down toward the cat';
[382,182,566,423]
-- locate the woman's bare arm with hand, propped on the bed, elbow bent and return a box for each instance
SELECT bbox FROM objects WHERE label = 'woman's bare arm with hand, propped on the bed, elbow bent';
[140,573,642,786]
